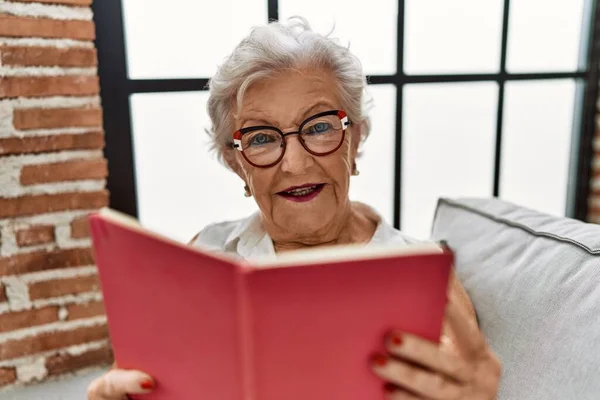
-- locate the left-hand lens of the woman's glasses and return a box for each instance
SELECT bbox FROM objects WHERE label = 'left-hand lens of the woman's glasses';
[242,129,283,165]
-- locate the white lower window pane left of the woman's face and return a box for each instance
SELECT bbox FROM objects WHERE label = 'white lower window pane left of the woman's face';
[131,92,257,242]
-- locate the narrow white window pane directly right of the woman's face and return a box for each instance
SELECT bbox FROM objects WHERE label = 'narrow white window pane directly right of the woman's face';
[350,85,396,224]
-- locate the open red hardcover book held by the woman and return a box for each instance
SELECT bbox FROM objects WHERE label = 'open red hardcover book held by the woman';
[90,209,452,400]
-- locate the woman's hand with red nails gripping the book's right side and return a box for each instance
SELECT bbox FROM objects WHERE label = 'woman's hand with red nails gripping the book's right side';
[372,301,502,400]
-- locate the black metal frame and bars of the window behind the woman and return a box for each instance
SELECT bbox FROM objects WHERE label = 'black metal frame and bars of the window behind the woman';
[92,0,600,228]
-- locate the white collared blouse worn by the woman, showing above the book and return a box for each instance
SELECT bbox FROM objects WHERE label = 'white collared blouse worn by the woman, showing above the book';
[191,211,419,259]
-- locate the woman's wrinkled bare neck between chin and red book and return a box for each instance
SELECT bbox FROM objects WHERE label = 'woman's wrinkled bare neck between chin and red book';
[271,203,380,253]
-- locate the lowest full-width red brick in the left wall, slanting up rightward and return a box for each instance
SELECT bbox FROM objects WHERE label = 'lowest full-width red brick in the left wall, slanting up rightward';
[0,324,109,360]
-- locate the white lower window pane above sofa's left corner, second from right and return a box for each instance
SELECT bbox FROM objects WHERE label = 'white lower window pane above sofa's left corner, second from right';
[402,82,498,239]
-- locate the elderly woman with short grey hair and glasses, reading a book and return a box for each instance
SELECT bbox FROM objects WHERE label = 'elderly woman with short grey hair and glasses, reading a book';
[88,19,501,400]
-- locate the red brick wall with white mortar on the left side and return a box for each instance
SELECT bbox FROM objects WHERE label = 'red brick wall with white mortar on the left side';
[0,0,112,390]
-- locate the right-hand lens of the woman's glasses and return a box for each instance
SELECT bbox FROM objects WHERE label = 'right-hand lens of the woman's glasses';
[302,115,344,154]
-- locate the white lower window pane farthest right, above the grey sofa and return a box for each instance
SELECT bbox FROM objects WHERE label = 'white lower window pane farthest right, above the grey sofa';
[500,80,575,216]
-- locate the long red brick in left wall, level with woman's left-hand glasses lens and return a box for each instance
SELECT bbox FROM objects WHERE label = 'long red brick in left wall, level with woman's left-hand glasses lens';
[0,132,105,155]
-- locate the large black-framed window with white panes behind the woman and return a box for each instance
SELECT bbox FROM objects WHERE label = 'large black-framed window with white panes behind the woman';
[94,0,599,241]
